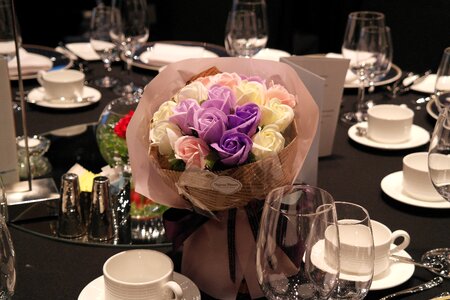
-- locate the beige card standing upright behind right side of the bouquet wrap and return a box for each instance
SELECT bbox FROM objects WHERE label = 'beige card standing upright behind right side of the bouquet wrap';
[281,55,350,157]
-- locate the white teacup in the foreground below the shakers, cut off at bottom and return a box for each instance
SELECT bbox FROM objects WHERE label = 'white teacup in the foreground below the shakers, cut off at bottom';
[103,249,183,300]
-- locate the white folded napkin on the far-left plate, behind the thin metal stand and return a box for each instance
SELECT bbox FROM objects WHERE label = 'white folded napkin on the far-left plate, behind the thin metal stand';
[8,48,53,76]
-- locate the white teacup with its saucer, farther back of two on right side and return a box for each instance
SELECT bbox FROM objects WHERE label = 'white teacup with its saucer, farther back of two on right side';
[348,104,430,150]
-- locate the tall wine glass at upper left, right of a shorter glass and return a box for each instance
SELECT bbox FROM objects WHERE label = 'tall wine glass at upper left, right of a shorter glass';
[111,0,149,98]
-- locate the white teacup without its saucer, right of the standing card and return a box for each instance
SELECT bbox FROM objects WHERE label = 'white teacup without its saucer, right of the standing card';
[367,104,414,144]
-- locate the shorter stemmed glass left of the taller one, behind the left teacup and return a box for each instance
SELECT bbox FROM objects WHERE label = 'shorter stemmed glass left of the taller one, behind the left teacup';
[90,3,118,88]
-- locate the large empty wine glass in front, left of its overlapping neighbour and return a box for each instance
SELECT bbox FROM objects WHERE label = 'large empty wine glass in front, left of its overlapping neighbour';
[256,185,339,299]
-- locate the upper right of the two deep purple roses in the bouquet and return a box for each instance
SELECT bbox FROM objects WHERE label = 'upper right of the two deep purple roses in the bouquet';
[228,102,261,136]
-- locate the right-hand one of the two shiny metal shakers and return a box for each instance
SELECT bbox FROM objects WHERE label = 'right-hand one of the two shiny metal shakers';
[88,176,116,242]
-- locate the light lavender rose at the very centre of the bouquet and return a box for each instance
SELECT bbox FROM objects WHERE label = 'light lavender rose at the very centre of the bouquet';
[192,107,228,144]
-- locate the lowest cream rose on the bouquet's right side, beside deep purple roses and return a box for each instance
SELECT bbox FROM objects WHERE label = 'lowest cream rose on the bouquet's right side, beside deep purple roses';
[252,125,285,160]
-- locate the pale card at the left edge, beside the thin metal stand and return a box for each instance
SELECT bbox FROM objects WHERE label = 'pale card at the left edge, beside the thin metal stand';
[0,59,19,185]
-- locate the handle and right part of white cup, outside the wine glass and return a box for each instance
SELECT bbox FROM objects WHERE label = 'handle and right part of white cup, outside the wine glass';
[370,220,411,276]
